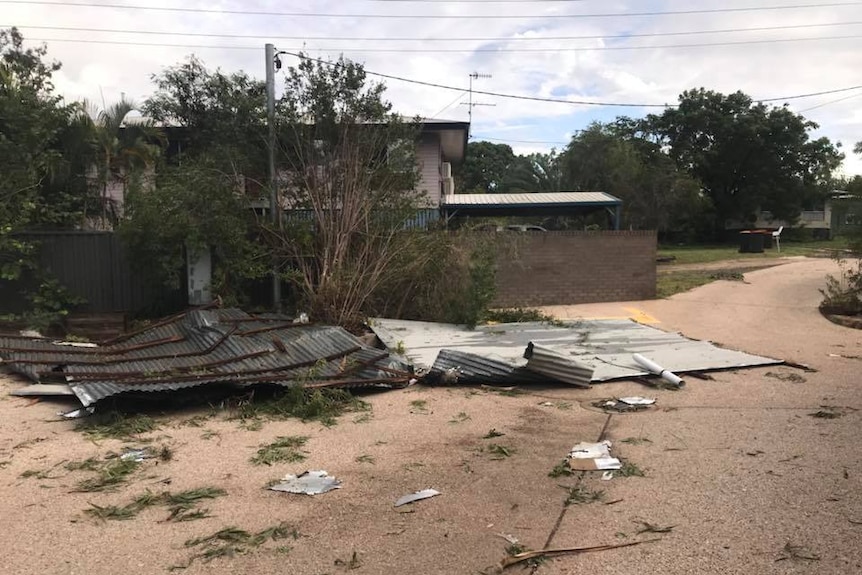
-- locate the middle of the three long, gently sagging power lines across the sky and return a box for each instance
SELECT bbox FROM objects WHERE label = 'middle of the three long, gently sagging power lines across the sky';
[11,20,862,42]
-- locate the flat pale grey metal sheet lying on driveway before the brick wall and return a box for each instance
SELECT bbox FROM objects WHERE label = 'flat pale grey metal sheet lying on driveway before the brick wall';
[370,318,783,382]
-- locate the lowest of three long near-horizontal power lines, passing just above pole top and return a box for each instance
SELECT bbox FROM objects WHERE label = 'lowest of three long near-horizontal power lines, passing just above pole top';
[23,34,862,54]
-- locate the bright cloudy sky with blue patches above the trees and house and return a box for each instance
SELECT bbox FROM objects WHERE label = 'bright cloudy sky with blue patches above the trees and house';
[6,0,862,174]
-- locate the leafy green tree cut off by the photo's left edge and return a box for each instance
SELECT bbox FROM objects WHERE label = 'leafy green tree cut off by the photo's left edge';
[0,28,88,279]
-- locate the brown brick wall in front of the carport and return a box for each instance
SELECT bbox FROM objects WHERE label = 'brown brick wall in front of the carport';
[494,231,656,307]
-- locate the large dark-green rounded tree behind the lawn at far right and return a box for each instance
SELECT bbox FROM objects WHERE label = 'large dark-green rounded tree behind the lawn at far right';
[646,88,843,227]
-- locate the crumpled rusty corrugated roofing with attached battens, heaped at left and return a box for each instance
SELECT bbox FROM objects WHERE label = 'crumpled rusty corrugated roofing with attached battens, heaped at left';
[0,309,412,406]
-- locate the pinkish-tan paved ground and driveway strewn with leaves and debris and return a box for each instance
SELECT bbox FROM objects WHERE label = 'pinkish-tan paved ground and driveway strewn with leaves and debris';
[0,259,862,575]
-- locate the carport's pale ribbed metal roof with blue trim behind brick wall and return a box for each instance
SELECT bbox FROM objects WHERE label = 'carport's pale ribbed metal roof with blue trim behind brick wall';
[440,192,623,230]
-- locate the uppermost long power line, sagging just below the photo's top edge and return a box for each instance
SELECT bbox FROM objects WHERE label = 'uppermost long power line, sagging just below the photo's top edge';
[0,0,862,20]
